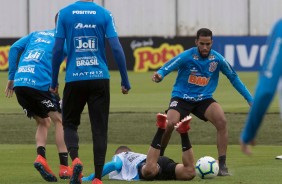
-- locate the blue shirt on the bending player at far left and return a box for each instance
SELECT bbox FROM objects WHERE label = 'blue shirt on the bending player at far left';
[8,30,58,91]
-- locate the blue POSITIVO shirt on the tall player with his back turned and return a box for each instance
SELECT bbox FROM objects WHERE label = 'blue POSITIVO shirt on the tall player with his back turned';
[53,1,118,82]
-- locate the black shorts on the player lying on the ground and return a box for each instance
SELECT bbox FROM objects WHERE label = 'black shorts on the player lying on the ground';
[138,156,177,180]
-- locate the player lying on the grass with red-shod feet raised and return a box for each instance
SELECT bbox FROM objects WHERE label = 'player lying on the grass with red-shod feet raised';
[83,113,196,181]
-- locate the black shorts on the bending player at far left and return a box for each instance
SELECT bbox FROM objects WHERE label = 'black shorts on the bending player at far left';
[14,86,61,118]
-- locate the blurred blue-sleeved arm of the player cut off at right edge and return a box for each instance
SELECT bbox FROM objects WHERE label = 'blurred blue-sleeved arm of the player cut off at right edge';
[240,19,282,159]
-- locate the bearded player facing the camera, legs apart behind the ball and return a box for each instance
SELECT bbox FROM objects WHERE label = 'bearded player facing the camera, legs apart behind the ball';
[152,28,253,176]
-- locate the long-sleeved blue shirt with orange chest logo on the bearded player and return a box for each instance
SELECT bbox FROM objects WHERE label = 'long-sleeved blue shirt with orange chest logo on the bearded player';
[157,47,253,103]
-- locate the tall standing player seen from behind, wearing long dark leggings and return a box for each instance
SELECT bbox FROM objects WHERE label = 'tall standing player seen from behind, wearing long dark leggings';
[50,0,130,184]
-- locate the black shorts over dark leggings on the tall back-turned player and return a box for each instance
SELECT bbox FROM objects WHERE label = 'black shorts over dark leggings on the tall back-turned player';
[62,79,110,130]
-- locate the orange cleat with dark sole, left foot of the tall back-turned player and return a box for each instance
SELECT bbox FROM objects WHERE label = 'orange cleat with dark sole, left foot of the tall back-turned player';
[70,158,83,184]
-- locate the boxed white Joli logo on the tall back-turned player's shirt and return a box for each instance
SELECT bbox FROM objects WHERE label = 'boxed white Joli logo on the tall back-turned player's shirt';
[74,36,98,52]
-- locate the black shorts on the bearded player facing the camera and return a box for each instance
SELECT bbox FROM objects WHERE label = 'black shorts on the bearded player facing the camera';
[166,97,216,121]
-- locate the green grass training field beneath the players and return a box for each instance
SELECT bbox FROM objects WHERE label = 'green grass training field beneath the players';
[0,72,282,184]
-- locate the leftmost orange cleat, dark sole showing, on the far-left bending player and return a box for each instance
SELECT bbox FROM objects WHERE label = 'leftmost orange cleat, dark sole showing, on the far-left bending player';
[33,155,57,182]
